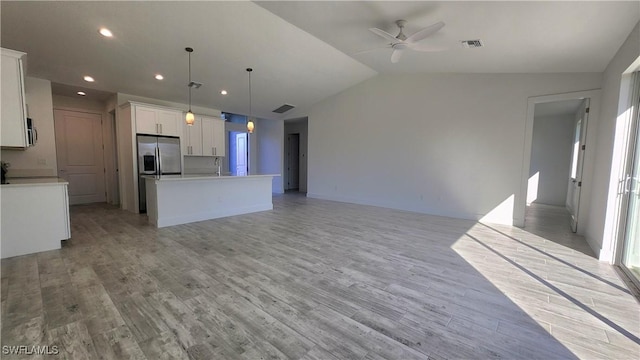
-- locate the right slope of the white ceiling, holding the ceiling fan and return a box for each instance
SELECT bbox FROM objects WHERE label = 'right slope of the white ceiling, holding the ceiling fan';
[258,1,640,73]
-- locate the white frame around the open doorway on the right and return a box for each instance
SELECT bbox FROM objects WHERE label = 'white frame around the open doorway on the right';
[513,89,602,231]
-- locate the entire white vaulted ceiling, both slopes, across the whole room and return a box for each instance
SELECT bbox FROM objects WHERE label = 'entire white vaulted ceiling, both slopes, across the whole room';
[0,1,640,119]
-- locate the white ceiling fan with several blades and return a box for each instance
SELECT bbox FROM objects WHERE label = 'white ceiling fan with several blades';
[365,20,444,64]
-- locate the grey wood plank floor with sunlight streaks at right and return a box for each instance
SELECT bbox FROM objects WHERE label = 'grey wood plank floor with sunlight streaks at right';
[1,194,640,360]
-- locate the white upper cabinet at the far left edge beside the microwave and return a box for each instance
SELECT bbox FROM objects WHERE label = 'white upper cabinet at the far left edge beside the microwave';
[0,49,28,148]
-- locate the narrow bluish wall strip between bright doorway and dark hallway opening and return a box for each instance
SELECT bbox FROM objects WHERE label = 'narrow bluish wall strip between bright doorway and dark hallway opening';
[256,119,284,194]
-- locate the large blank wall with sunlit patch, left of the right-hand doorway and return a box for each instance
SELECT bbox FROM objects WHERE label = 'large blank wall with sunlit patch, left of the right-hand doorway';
[307,73,602,224]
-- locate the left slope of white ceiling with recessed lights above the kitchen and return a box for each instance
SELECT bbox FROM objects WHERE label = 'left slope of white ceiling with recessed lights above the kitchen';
[0,1,376,118]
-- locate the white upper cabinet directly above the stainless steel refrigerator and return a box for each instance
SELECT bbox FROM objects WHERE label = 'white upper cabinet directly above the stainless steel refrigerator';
[135,104,182,136]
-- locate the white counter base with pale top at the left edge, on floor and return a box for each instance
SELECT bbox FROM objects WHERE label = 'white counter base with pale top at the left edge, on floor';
[0,177,71,259]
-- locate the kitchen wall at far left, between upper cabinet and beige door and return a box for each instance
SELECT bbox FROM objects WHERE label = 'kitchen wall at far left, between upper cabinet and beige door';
[1,77,58,177]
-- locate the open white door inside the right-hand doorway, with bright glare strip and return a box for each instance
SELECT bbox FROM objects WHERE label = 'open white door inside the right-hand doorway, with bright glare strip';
[567,99,589,232]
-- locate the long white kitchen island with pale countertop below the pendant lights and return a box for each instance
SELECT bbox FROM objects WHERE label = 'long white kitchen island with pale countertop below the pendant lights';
[144,174,278,228]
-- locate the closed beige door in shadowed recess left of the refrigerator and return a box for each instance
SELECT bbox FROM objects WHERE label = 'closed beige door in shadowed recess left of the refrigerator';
[54,110,106,205]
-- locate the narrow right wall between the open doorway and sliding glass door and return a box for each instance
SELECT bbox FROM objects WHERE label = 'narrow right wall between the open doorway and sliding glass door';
[585,23,640,261]
